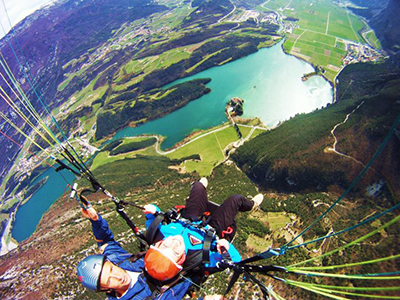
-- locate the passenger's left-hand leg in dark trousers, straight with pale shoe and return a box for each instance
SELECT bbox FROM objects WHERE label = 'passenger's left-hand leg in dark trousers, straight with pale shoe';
[182,178,208,219]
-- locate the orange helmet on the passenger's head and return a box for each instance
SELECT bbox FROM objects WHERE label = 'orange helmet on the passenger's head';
[144,246,182,281]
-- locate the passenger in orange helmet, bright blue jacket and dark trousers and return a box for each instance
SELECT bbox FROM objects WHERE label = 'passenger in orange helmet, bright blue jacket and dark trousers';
[144,178,263,281]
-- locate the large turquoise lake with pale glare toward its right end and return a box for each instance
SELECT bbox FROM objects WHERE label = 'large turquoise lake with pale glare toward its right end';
[5,40,332,247]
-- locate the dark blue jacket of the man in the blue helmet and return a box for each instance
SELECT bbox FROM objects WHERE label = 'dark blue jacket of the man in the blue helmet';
[91,215,192,300]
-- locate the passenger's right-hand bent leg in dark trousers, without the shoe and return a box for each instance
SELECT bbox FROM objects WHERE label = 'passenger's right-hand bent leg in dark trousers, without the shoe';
[209,195,254,241]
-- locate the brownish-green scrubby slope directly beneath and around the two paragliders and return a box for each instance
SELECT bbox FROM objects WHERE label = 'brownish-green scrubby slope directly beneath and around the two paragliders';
[0,95,399,299]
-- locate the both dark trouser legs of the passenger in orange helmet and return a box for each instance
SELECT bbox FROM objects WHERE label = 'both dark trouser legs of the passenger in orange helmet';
[182,181,254,241]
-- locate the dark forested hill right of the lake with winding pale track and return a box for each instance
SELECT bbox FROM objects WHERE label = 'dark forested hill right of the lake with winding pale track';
[234,57,400,199]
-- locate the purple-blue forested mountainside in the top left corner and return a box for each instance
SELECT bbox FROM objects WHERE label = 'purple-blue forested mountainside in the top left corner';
[0,0,166,106]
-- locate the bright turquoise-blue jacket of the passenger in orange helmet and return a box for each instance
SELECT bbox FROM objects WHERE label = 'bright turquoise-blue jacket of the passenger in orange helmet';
[146,204,242,267]
